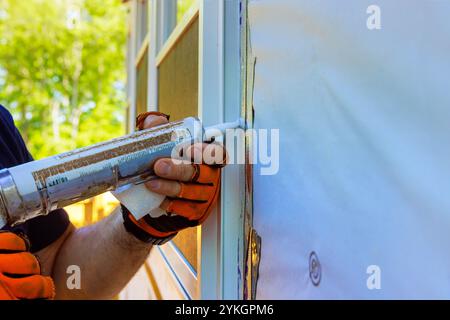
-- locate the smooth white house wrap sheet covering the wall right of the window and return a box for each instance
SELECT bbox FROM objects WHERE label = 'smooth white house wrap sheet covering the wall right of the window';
[249,0,450,299]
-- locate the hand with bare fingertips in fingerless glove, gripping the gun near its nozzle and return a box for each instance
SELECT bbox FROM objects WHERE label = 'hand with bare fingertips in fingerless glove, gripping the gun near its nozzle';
[122,112,225,244]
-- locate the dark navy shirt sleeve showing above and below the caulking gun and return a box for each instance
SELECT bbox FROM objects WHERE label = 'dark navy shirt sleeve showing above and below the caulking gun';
[0,106,70,252]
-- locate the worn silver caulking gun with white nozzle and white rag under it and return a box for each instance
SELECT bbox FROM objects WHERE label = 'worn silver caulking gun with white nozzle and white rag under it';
[0,117,242,228]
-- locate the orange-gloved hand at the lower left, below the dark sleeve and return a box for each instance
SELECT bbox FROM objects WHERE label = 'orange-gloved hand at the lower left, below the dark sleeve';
[0,231,55,300]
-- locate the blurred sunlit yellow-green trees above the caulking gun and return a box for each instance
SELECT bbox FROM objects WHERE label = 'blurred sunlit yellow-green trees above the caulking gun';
[0,0,126,158]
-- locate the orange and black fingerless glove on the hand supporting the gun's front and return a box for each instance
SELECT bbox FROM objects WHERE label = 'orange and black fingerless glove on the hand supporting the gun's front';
[122,112,222,245]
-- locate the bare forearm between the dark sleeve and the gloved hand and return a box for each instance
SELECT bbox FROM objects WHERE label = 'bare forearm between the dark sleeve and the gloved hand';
[52,209,151,299]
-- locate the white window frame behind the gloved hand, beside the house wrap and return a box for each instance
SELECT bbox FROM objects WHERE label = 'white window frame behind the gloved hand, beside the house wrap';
[123,0,245,299]
